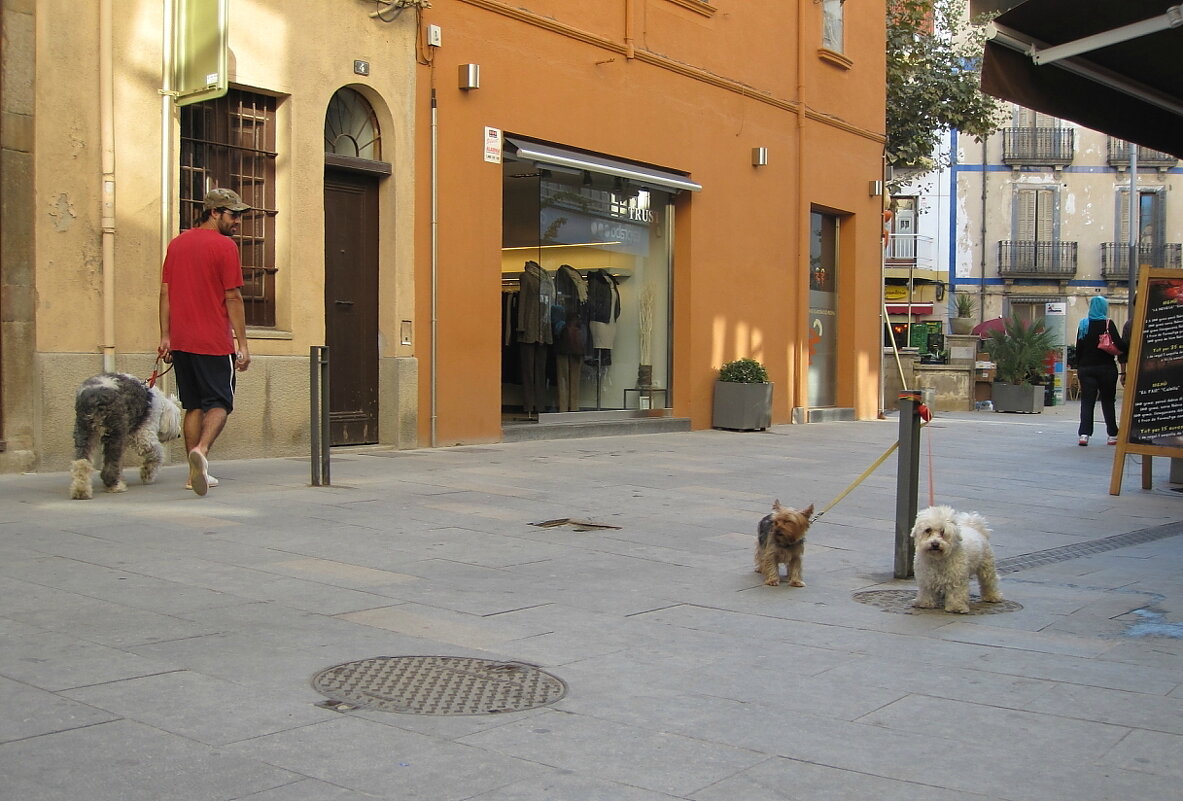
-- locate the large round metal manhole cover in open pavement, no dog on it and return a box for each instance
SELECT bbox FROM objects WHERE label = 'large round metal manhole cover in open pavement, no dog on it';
[312,657,567,715]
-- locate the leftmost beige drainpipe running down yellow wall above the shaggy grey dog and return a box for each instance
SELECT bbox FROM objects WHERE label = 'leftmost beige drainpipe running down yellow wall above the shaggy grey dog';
[98,0,115,373]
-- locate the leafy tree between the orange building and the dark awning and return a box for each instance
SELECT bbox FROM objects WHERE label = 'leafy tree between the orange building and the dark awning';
[886,0,1002,176]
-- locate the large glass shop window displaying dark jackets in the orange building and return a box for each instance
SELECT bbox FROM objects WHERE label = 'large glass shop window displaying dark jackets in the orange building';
[500,159,673,420]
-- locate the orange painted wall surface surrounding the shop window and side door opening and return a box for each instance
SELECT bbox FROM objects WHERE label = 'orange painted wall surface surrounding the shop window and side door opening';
[416,0,884,445]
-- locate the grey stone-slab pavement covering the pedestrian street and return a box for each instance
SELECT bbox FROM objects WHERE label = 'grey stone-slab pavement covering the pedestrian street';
[0,402,1183,801]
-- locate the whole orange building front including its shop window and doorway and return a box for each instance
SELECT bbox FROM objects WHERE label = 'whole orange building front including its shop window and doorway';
[416,0,884,445]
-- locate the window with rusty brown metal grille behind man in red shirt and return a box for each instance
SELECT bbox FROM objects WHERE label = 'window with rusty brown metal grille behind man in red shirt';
[180,89,277,327]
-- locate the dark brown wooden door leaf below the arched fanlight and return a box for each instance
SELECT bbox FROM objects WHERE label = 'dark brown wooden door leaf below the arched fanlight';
[324,169,379,445]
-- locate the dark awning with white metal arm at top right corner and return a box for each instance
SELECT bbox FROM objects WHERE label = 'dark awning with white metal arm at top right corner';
[982,0,1183,157]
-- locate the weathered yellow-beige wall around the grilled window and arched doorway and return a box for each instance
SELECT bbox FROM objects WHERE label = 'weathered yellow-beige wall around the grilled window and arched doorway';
[13,0,419,471]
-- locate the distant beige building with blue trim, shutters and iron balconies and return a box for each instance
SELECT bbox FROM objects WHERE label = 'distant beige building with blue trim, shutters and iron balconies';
[950,106,1183,333]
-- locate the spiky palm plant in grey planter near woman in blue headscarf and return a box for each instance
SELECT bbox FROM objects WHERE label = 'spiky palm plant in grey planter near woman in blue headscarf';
[987,316,1059,414]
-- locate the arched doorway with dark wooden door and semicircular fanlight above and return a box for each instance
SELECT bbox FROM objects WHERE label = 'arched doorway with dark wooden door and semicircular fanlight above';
[324,88,390,445]
